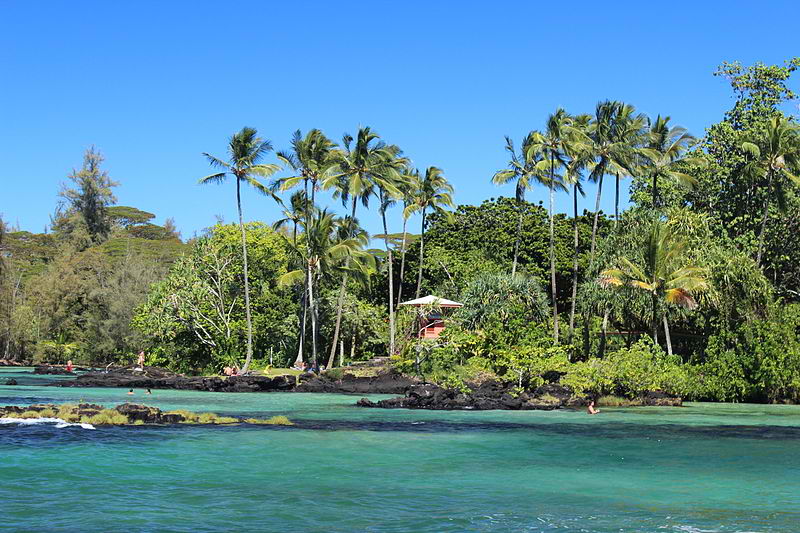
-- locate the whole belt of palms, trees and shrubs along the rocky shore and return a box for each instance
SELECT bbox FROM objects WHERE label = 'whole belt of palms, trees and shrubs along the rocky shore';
[0,58,800,409]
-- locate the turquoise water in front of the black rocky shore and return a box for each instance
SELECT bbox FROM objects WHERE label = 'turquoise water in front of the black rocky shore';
[0,369,800,532]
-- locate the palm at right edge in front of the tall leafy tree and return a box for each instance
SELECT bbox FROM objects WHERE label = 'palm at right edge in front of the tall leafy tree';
[741,115,800,266]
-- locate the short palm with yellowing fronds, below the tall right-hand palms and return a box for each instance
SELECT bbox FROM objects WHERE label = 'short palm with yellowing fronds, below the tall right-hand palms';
[600,220,708,354]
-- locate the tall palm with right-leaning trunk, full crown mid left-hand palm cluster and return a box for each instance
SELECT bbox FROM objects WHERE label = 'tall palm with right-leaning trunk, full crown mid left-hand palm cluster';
[322,127,400,361]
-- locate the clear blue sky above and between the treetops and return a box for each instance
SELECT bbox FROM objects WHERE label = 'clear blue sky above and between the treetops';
[0,0,800,237]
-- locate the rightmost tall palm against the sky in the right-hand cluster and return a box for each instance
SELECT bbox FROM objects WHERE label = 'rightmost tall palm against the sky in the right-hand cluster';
[641,115,706,209]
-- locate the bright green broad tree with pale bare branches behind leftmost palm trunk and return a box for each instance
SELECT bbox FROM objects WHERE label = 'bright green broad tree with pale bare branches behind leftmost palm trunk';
[134,223,298,371]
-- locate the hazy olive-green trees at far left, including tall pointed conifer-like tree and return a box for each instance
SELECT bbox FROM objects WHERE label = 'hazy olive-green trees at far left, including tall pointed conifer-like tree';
[0,152,185,364]
